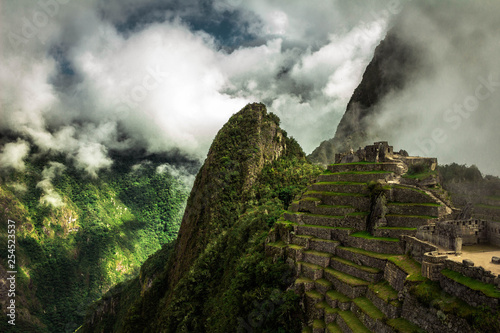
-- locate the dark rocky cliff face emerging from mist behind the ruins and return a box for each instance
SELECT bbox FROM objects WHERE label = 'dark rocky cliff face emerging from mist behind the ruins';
[308,29,418,165]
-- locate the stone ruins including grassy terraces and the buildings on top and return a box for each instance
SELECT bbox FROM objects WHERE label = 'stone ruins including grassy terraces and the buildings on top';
[266,142,500,333]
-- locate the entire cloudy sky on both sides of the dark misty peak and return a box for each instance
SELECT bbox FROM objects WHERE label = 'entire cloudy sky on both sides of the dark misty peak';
[0,0,500,176]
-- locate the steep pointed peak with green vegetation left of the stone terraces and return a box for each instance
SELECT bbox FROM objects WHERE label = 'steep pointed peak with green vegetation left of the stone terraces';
[81,104,320,332]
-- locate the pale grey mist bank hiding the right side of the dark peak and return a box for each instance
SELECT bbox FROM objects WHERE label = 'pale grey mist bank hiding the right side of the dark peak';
[364,1,500,175]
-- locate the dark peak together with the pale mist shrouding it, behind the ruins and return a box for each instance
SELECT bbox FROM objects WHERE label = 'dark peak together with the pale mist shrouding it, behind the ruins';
[310,1,500,175]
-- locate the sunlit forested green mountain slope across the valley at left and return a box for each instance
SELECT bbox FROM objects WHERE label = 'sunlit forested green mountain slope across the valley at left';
[0,152,188,332]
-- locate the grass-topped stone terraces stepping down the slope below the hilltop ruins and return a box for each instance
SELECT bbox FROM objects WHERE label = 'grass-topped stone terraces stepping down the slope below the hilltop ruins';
[266,162,454,333]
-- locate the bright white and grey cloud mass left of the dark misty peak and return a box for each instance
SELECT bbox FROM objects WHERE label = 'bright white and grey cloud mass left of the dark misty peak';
[0,0,394,177]
